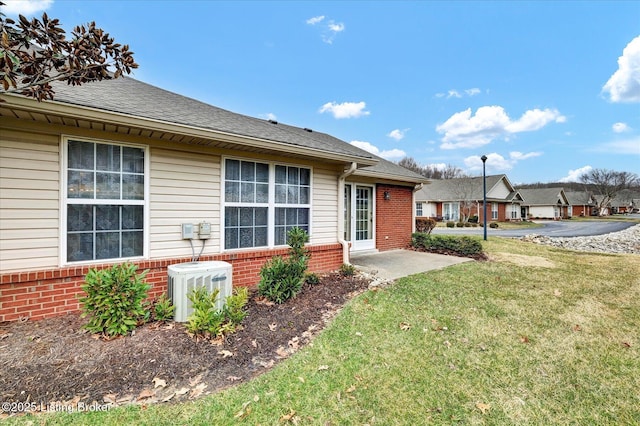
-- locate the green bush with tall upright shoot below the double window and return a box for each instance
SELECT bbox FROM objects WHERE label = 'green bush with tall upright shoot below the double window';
[258,228,309,303]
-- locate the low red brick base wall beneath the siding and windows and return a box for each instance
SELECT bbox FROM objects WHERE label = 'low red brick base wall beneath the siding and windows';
[0,244,342,322]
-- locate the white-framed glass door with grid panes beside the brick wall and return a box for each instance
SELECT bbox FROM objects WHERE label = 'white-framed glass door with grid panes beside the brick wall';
[344,184,376,251]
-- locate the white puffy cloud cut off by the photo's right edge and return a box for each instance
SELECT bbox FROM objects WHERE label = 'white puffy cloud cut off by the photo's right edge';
[602,36,640,102]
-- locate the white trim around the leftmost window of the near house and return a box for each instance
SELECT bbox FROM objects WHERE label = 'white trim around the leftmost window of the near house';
[58,135,151,267]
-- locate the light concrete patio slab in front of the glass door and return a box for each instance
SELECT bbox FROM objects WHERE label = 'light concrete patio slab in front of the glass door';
[351,250,472,280]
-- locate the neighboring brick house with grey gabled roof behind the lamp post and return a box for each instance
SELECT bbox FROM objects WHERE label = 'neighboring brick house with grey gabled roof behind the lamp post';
[416,174,522,222]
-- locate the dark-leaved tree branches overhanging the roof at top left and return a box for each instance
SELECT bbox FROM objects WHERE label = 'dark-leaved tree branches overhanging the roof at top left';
[0,2,138,101]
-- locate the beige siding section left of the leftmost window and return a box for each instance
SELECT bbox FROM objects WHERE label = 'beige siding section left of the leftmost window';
[0,128,60,272]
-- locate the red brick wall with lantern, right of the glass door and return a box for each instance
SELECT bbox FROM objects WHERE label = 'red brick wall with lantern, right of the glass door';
[376,185,413,251]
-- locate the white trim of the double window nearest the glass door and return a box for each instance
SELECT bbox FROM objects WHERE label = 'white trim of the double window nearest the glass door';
[220,156,313,253]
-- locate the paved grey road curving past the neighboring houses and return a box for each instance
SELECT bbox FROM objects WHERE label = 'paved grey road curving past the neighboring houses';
[433,220,637,238]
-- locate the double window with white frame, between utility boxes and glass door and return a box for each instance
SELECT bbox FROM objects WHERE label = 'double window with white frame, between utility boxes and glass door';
[224,159,311,249]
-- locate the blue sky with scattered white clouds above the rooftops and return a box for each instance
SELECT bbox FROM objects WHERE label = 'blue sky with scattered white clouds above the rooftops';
[3,0,640,184]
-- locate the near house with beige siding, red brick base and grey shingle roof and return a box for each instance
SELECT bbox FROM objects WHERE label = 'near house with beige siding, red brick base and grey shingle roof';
[0,78,426,321]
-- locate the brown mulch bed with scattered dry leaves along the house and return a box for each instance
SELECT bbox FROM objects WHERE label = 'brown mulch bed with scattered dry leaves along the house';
[0,273,369,419]
